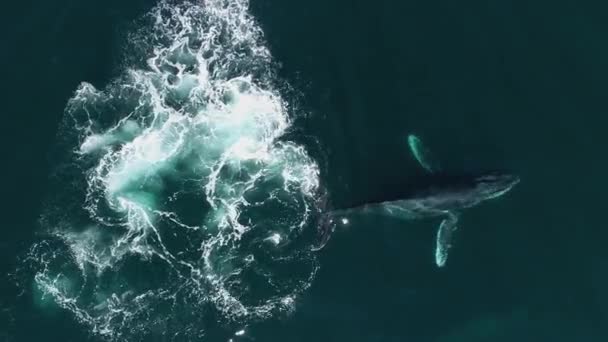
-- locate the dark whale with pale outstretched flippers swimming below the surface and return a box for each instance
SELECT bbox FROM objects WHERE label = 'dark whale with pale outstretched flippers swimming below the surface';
[316,135,519,267]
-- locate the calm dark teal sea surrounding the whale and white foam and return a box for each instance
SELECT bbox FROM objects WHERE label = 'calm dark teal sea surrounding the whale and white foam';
[0,0,608,341]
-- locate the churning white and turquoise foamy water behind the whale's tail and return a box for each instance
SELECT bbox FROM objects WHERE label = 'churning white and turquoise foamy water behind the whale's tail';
[28,0,319,341]
